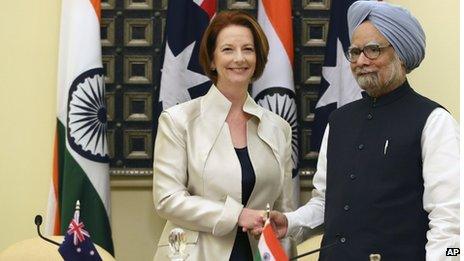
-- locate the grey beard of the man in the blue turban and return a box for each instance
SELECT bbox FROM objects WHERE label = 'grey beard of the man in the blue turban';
[354,55,402,97]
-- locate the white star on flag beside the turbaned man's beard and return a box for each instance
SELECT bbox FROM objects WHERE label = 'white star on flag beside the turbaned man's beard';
[316,38,362,108]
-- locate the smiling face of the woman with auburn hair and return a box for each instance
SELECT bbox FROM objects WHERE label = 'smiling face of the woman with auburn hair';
[211,25,256,85]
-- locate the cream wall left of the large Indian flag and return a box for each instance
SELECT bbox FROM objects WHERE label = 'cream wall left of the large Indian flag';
[0,0,60,249]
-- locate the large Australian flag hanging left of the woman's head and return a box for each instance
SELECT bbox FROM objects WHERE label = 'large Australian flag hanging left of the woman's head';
[157,0,216,111]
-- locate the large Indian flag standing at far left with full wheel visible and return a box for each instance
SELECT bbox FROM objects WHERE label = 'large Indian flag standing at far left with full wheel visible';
[46,0,114,254]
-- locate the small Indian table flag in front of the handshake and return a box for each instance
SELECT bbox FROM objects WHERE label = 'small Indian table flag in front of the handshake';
[254,221,288,261]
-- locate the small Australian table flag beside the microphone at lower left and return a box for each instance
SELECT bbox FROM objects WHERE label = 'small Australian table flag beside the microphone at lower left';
[58,201,102,261]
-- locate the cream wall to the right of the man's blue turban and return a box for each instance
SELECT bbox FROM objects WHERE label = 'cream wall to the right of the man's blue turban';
[388,0,460,119]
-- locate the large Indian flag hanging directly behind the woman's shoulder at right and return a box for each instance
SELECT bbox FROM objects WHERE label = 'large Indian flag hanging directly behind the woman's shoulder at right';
[252,0,300,208]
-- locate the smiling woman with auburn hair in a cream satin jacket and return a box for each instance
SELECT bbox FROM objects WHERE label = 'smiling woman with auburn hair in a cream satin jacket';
[153,11,292,260]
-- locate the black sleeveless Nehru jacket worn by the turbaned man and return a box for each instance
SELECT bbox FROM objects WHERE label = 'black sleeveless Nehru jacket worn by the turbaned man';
[320,81,440,261]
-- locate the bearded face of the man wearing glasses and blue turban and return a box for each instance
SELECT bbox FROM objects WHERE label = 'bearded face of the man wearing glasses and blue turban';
[350,21,405,97]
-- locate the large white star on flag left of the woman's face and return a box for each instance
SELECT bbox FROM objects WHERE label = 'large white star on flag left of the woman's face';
[159,42,209,109]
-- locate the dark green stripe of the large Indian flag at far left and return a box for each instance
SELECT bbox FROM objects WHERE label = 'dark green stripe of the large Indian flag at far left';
[58,120,114,256]
